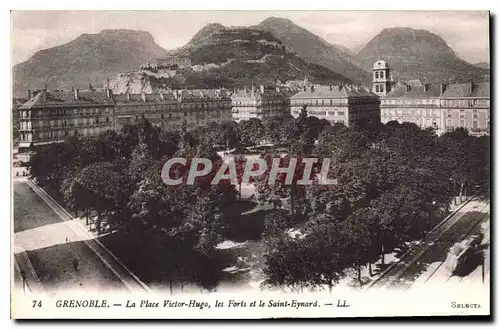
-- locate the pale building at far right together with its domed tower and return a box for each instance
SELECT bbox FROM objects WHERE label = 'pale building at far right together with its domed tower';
[373,61,490,135]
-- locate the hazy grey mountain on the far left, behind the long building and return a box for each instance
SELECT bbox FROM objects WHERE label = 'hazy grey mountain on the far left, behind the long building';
[12,30,167,95]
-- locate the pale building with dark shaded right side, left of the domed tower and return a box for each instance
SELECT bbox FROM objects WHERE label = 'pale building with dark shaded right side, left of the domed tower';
[291,85,380,125]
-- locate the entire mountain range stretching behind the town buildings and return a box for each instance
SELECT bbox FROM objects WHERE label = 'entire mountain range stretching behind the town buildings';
[13,17,489,95]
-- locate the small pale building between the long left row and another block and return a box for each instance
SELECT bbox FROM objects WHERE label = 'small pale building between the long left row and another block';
[231,85,291,122]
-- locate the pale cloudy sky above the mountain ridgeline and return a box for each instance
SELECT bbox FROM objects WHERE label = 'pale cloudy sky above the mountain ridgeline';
[11,11,490,65]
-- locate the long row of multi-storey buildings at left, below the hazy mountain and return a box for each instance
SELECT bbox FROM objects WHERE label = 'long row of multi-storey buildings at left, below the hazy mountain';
[18,89,231,148]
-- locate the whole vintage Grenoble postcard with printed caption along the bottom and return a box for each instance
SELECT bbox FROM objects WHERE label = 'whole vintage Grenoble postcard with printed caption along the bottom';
[10,11,491,319]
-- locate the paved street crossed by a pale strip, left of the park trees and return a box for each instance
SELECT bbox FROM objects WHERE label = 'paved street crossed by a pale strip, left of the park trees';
[14,181,146,293]
